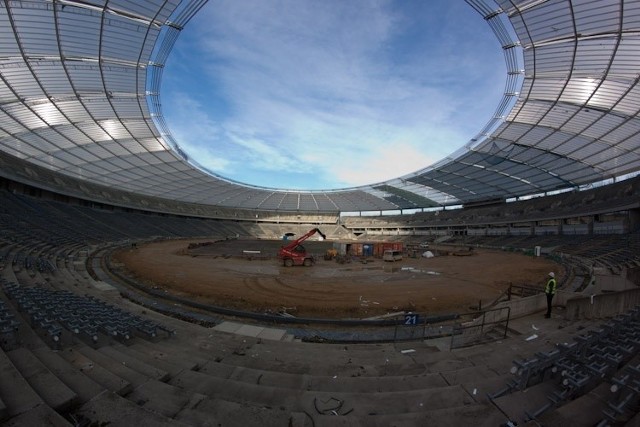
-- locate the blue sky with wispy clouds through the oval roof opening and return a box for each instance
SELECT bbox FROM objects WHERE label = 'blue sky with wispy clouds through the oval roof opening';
[161,0,506,190]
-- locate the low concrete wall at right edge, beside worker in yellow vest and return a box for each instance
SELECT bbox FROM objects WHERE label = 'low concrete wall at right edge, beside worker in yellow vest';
[565,289,640,320]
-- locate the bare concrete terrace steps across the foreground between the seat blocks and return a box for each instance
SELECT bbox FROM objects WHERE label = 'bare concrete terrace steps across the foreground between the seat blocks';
[0,242,638,427]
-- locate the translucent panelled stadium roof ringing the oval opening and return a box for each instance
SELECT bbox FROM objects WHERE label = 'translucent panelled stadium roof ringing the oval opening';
[0,0,640,212]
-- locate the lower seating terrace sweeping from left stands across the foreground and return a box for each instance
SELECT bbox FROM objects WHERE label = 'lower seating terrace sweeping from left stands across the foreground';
[0,192,640,427]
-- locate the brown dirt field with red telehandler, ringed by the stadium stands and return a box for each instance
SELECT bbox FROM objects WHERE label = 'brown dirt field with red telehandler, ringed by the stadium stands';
[113,240,562,318]
